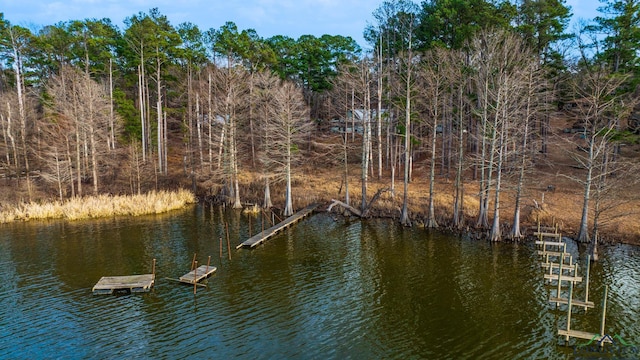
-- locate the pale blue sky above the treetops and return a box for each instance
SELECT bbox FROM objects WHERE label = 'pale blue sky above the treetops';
[0,0,600,48]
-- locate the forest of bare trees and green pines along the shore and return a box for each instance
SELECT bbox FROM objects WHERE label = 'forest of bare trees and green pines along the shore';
[0,0,640,250]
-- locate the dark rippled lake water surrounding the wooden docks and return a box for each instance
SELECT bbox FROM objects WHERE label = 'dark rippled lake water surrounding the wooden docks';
[0,206,640,359]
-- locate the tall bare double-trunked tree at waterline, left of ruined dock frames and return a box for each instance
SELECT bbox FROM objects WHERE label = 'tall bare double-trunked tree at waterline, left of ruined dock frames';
[471,30,534,241]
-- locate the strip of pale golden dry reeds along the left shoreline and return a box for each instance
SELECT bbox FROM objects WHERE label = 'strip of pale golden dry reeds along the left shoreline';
[0,189,196,223]
